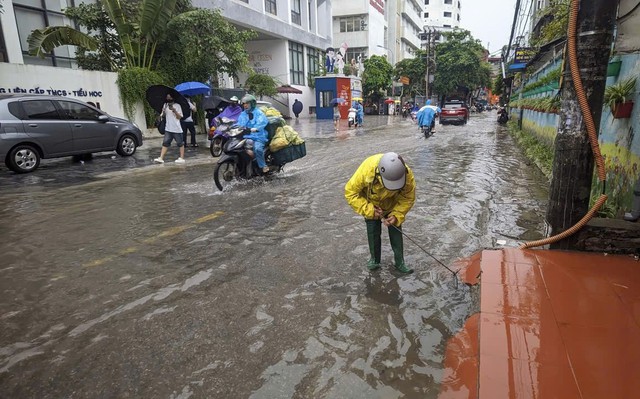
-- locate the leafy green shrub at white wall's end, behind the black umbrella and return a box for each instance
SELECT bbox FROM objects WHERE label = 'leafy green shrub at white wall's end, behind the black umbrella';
[116,67,167,126]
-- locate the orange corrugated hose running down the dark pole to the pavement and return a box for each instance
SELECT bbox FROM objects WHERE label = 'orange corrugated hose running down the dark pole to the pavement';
[520,0,607,249]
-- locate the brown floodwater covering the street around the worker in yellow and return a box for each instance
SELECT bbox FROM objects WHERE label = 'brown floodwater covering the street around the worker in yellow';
[0,112,548,399]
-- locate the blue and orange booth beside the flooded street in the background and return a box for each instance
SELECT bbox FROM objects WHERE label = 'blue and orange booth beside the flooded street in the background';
[315,75,362,119]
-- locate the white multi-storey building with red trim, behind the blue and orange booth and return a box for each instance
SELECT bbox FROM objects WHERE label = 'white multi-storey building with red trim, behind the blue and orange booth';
[333,0,422,65]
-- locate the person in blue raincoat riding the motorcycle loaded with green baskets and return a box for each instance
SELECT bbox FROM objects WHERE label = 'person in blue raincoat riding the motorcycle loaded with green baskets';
[237,94,269,173]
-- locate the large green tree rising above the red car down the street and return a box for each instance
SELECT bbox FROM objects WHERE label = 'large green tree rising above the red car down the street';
[433,29,491,96]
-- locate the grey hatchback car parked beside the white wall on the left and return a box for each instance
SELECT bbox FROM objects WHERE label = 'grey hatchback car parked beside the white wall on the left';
[0,94,142,173]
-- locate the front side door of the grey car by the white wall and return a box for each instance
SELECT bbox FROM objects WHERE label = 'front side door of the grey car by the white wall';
[57,100,118,152]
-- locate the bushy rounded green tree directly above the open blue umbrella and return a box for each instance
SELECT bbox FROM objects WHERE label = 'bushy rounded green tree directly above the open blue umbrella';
[158,9,256,83]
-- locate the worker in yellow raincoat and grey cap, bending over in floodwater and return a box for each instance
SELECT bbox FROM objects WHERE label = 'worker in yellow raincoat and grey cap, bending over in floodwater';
[344,152,416,273]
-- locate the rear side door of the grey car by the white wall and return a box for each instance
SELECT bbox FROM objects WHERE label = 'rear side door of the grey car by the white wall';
[21,99,73,157]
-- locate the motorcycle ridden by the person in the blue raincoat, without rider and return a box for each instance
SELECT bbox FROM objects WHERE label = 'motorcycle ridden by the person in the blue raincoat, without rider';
[213,126,282,191]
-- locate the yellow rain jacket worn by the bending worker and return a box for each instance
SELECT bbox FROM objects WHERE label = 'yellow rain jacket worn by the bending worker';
[344,154,416,226]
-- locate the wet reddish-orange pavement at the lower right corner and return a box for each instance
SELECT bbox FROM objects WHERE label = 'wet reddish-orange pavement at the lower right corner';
[439,248,640,399]
